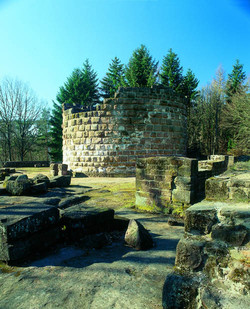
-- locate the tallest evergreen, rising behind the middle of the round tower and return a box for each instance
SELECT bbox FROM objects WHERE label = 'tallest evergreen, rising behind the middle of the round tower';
[125,45,158,87]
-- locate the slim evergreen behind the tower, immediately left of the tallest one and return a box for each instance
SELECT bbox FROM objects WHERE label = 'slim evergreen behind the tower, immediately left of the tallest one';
[101,57,125,97]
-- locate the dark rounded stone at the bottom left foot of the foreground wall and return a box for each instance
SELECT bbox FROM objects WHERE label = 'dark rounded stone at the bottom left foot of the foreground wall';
[162,273,199,309]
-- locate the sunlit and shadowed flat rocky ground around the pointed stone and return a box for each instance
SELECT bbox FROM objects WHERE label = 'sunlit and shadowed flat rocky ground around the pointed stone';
[0,173,183,309]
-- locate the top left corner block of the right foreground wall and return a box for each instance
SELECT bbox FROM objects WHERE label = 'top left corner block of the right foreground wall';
[185,203,218,234]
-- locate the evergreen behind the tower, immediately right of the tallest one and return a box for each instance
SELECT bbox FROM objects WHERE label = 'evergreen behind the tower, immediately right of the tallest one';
[160,48,183,92]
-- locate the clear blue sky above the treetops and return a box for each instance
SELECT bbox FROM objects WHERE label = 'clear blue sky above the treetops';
[0,0,250,106]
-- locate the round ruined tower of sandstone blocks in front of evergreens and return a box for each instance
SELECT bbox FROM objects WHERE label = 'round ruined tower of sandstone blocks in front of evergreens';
[63,87,186,176]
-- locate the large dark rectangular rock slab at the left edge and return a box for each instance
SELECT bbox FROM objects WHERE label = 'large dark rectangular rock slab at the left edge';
[0,203,59,261]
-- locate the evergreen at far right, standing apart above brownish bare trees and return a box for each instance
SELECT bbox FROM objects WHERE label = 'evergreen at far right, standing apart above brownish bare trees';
[226,59,246,103]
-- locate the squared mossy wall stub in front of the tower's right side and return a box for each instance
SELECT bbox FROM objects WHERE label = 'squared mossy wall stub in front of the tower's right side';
[136,156,233,213]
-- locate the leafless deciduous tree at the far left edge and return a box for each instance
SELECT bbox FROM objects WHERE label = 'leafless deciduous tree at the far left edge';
[0,78,40,161]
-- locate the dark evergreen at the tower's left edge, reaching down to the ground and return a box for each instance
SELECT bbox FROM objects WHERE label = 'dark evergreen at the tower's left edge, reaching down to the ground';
[49,59,100,161]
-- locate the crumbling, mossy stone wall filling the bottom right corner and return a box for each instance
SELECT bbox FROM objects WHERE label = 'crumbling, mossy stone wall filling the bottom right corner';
[163,202,250,309]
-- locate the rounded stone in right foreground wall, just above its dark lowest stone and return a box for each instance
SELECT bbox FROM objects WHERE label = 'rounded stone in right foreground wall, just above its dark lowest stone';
[175,238,205,270]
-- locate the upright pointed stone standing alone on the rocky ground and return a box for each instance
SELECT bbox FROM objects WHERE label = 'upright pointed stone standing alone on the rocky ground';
[125,220,153,250]
